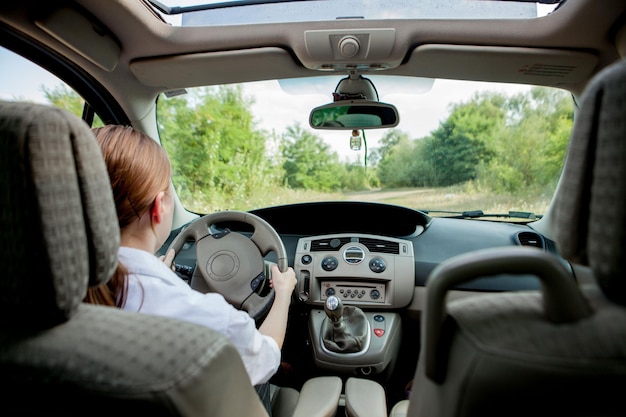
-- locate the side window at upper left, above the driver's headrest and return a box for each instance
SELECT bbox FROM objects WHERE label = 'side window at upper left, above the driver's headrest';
[0,46,103,126]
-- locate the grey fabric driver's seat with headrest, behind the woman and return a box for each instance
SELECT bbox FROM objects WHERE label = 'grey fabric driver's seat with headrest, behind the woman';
[0,101,341,417]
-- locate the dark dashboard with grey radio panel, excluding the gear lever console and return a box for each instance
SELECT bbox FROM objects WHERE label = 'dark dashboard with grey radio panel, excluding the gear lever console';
[164,201,565,300]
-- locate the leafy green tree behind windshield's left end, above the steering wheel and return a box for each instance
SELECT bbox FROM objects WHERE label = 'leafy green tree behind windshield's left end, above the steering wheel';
[158,86,277,212]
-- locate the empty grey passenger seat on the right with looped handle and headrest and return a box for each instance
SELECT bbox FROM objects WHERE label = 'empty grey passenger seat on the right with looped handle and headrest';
[392,62,626,417]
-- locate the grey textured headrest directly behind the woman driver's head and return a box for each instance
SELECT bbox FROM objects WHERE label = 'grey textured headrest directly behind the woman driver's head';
[0,101,120,331]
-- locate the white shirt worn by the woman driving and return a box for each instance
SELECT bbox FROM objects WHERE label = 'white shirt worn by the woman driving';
[118,247,280,385]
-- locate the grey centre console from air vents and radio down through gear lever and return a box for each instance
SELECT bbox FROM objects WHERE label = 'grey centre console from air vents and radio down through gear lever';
[294,234,415,377]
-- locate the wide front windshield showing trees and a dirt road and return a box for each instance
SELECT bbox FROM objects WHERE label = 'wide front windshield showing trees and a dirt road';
[158,76,574,221]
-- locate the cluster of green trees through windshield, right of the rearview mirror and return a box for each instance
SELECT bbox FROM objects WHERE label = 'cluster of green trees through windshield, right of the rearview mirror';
[370,87,573,193]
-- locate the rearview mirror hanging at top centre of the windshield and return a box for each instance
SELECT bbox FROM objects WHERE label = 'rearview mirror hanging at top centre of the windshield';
[309,99,400,130]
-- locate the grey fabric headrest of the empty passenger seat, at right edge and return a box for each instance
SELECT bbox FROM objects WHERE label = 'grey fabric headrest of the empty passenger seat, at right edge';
[553,61,626,304]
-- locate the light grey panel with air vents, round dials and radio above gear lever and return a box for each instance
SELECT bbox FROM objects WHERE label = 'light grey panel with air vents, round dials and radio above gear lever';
[294,233,415,309]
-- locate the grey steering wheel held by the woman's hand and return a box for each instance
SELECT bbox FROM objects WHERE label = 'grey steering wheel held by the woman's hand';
[163,210,289,321]
